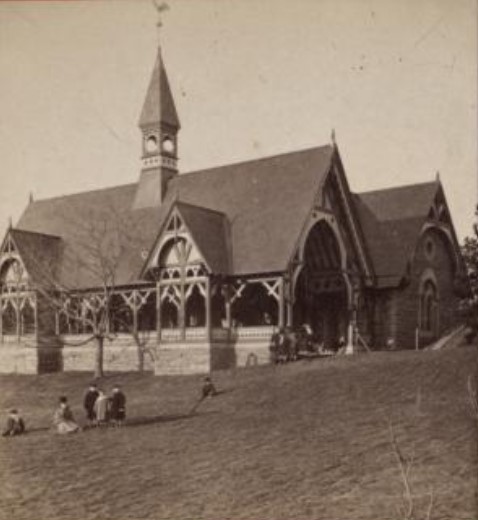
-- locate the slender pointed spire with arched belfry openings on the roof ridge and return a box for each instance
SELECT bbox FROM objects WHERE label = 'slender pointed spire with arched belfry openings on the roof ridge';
[133,47,180,209]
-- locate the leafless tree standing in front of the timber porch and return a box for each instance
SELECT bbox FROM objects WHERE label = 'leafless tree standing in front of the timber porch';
[9,206,156,377]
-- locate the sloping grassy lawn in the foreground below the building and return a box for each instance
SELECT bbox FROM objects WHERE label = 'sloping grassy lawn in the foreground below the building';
[0,347,478,520]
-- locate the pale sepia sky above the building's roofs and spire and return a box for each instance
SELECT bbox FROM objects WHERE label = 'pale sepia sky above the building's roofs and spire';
[0,0,478,243]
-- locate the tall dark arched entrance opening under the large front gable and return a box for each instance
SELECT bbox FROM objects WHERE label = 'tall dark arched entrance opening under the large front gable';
[293,221,350,348]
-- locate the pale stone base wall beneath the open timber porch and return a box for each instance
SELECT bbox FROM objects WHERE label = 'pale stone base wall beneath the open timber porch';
[0,329,271,375]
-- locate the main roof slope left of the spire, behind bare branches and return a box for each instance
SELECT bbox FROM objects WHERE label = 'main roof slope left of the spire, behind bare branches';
[17,184,159,289]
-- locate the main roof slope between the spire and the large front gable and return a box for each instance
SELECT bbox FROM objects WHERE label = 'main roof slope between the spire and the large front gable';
[168,145,333,275]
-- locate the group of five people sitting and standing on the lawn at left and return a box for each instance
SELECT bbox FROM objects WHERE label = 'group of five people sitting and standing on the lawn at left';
[2,383,126,437]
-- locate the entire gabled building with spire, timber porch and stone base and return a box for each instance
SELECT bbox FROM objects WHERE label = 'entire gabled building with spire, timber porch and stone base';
[0,44,464,374]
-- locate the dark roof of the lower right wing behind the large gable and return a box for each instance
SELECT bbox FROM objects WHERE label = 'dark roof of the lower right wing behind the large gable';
[354,182,439,287]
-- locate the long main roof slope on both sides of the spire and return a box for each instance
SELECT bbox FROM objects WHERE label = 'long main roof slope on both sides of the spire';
[17,146,333,288]
